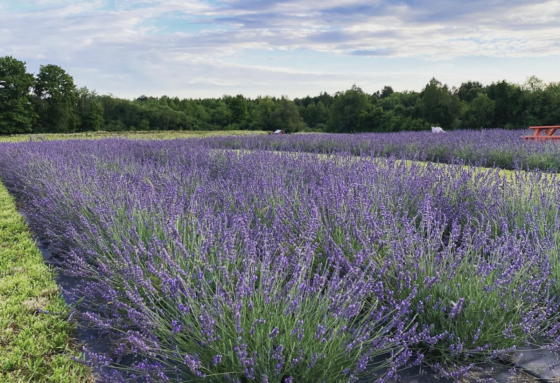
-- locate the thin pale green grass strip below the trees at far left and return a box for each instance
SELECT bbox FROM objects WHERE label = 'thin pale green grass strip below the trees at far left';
[0,130,267,142]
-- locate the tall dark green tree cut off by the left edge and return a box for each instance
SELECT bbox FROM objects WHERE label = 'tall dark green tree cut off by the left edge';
[0,56,37,134]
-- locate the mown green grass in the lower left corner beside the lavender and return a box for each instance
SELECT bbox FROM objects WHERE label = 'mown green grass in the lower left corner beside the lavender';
[0,183,94,383]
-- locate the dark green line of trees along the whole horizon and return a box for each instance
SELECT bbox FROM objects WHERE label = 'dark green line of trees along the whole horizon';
[0,56,560,134]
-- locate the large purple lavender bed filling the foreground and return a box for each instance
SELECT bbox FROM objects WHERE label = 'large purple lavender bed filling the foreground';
[0,139,560,383]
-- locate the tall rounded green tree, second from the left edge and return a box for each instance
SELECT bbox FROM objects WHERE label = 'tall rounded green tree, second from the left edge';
[35,64,79,133]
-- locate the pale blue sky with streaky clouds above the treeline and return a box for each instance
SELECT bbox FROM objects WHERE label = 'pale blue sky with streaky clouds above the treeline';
[0,0,560,98]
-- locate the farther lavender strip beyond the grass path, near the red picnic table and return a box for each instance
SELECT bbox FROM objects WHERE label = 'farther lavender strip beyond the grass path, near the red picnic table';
[198,129,560,172]
